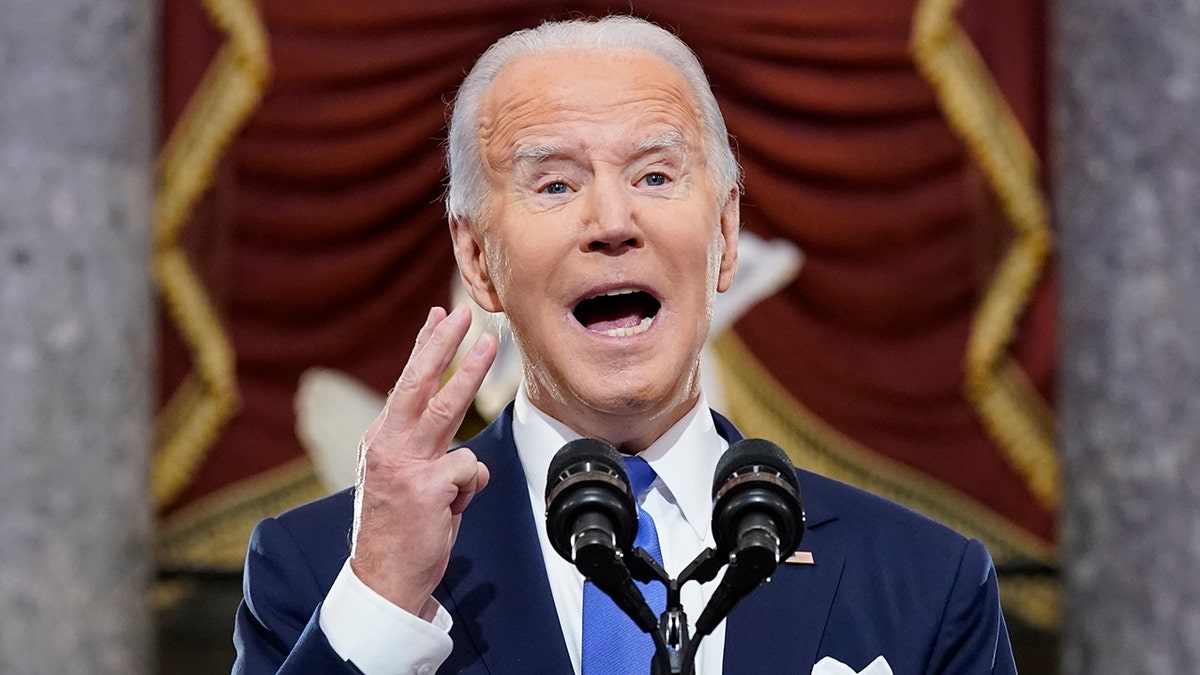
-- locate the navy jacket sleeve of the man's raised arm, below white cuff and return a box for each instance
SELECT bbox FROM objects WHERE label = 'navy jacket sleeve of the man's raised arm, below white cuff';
[233,511,361,675]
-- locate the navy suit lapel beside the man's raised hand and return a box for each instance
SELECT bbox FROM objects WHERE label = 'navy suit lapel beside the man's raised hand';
[443,406,571,674]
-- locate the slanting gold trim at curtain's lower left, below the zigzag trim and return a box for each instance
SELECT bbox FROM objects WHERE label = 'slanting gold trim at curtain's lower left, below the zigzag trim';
[155,459,333,571]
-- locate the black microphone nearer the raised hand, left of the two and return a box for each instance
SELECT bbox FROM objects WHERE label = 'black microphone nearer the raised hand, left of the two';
[546,438,659,635]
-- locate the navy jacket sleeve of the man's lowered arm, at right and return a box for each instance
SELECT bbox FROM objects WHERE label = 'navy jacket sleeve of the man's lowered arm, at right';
[929,539,1016,675]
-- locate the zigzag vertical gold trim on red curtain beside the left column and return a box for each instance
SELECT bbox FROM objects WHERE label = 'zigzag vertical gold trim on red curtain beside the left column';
[150,0,270,507]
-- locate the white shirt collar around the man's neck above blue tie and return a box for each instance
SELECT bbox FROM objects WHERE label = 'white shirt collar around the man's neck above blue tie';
[512,383,728,539]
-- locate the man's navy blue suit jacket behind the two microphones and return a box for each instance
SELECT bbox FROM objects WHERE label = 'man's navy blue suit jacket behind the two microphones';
[234,406,1016,675]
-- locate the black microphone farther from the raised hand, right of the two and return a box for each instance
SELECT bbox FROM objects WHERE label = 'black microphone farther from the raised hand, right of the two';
[696,438,804,638]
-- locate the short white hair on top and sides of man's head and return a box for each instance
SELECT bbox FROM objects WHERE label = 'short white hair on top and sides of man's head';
[446,16,740,223]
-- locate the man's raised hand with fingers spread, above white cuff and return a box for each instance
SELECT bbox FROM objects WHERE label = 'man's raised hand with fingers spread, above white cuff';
[350,306,496,619]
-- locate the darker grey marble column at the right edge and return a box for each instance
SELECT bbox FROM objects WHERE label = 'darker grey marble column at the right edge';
[1051,0,1200,675]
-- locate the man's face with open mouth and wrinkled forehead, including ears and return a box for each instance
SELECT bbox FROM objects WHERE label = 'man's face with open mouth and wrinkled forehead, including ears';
[455,50,738,450]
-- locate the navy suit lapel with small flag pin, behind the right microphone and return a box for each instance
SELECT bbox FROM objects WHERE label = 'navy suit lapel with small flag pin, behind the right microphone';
[725,472,845,675]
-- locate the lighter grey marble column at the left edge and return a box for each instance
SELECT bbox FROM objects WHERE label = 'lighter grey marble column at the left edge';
[0,0,157,675]
